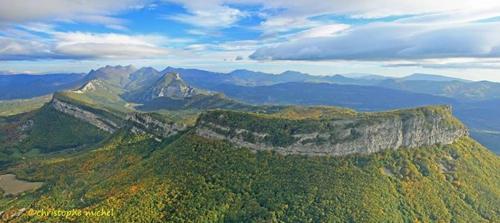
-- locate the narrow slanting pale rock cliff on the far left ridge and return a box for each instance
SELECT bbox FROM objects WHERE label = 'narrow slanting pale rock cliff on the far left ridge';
[50,98,120,133]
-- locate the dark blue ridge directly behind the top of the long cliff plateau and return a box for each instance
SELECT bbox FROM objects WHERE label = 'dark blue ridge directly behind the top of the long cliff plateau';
[207,82,455,111]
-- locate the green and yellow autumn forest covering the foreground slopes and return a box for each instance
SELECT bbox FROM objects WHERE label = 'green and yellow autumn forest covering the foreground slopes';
[0,126,500,222]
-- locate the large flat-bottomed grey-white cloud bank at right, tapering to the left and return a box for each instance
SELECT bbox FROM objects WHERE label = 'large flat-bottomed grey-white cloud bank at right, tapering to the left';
[251,23,500,60]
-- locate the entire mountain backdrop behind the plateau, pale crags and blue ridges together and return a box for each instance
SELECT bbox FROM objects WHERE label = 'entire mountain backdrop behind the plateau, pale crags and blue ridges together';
[0,66,500,151]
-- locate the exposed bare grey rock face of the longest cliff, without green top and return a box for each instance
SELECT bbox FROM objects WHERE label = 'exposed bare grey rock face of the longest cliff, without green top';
[195,107,469,156]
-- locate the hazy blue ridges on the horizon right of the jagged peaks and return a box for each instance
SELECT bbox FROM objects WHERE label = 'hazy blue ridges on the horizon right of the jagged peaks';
[162,67,500,101]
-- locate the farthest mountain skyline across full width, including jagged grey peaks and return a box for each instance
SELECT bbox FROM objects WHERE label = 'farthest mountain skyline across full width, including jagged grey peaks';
[0,66,500,101]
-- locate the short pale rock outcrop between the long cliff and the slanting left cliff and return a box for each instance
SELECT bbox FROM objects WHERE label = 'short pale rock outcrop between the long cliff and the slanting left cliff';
[127,113,186,138]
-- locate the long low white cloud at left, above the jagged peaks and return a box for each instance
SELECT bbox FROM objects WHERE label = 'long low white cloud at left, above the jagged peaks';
[0,32,168,60]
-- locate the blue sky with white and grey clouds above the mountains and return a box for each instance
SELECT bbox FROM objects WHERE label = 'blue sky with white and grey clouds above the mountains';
[0,0,500,81]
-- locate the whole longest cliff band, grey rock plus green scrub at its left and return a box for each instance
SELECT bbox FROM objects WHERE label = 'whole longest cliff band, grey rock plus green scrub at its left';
[196,106,468,156]
